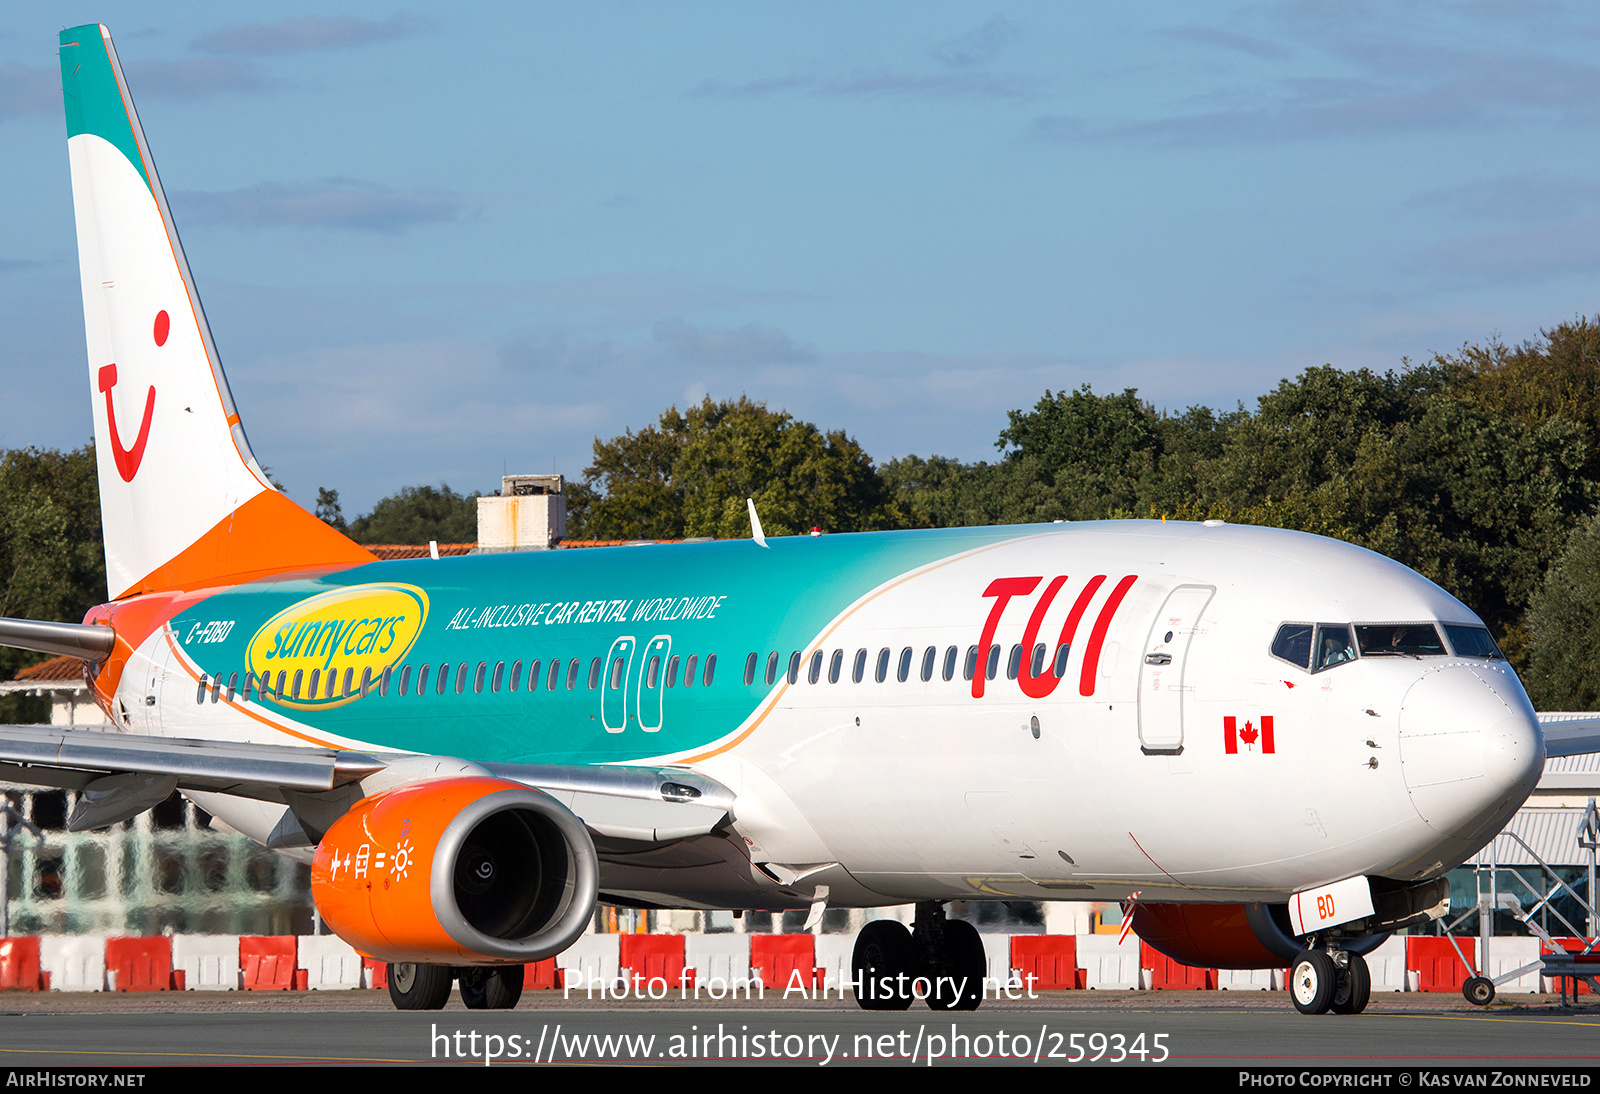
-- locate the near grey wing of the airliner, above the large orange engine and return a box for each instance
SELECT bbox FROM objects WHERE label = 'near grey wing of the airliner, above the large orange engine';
[0,725,733,843]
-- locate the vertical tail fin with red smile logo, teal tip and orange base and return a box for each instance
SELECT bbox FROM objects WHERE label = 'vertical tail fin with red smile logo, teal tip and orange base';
[61,24,373,598]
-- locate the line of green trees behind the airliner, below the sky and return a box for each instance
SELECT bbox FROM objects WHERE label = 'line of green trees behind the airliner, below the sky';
[9,317,1600,710]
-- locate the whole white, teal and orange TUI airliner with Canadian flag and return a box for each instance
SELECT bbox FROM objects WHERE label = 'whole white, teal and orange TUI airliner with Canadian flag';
[0,26,1581,1012]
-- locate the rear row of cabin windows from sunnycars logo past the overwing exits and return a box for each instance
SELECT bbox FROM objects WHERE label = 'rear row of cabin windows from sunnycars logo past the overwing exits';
[195,654,717,702]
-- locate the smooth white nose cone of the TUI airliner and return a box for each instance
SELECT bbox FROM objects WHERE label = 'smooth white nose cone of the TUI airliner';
[1400,664,1544,854]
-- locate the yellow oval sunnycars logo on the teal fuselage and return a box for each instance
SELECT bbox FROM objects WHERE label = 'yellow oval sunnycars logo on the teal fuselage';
[246,584,427,710]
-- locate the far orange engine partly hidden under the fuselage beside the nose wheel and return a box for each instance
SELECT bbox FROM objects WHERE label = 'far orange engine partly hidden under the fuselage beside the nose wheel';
[1133,904,1304,969]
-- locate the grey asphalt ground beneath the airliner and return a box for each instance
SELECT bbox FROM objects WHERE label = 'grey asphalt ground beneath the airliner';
[0,992,1600,1068]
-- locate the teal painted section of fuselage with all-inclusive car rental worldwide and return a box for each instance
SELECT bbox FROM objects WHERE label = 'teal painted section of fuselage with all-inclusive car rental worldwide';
[173,528,1040,763]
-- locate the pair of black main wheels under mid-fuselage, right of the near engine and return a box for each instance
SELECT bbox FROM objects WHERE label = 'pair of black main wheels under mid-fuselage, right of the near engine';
[850,900,989,1011]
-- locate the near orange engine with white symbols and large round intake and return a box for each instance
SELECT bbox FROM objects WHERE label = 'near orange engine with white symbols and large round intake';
[310,776,598,964]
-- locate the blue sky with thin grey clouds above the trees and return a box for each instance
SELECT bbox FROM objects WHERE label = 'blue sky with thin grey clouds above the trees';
[0,0,1600,515]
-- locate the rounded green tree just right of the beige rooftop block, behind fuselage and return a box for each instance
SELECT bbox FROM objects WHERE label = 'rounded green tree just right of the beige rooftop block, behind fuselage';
[584,397,902,539]
